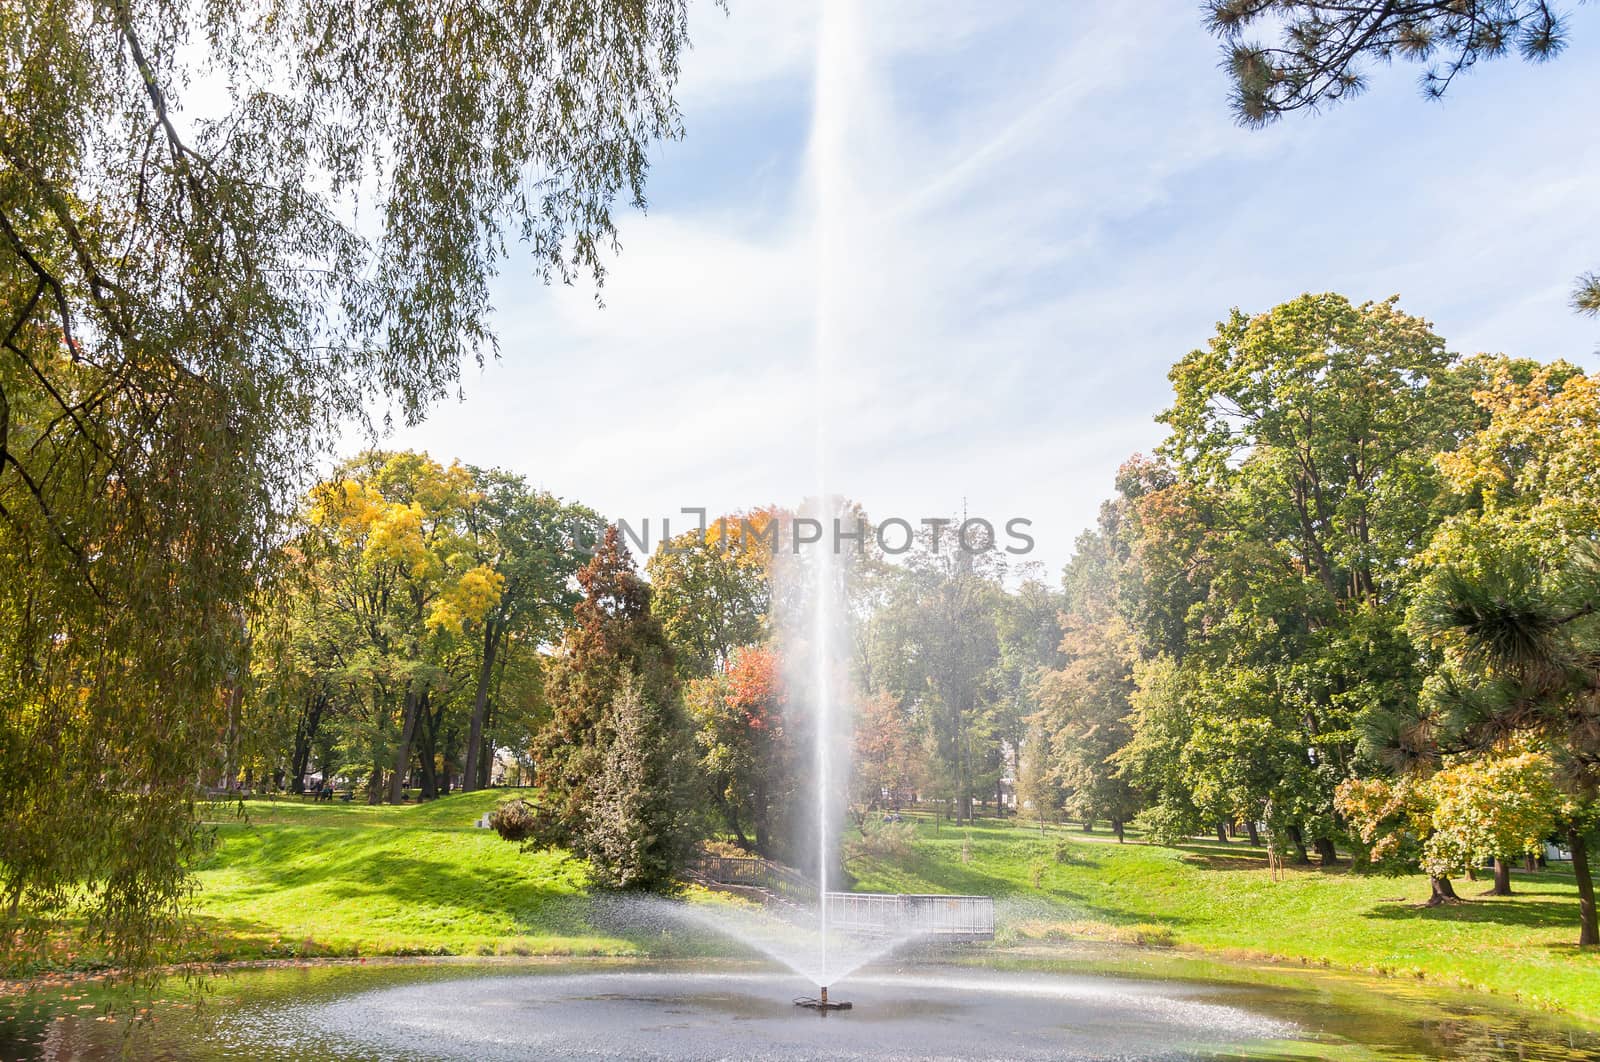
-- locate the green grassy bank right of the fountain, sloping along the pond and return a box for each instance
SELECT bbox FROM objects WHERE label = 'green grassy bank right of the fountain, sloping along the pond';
[851,822,1600,1020]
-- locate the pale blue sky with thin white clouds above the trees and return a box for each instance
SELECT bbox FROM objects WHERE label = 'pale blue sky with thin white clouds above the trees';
[384,0,1600,579]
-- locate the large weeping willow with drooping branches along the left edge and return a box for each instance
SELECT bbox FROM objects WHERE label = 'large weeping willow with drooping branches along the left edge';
[0,0,686,968]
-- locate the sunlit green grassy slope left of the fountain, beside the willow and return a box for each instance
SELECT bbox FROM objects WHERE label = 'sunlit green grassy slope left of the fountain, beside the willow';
[192,793,638,960]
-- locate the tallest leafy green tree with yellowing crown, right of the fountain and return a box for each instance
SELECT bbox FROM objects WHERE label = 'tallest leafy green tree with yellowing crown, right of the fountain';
[1142,294,1475,862]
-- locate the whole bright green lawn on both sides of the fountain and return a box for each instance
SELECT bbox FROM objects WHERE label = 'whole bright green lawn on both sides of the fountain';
[189,793,1600,1020]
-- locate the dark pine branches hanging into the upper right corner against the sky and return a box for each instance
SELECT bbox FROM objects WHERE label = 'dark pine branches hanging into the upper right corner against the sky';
[1205,0,1600,313]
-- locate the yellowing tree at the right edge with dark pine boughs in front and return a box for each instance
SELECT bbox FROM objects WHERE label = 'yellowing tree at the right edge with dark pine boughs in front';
[1408,363,1600,945]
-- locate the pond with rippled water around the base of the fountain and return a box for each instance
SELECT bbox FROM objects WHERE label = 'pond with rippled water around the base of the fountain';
[9,948,1600,1059]
